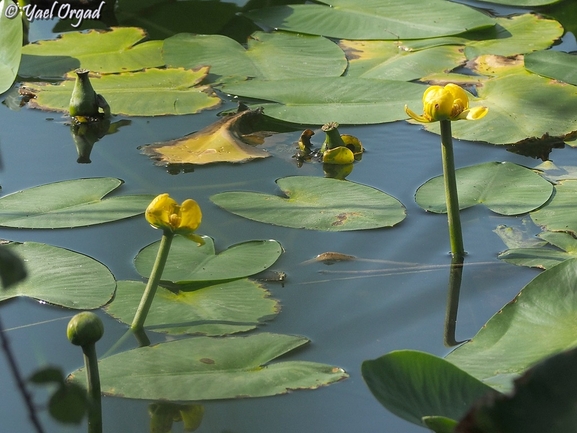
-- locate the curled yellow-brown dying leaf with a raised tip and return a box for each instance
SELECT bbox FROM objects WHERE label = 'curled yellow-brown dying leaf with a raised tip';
[142,106,270,165]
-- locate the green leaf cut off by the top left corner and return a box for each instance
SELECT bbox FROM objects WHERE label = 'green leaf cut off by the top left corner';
[0,0,22,93]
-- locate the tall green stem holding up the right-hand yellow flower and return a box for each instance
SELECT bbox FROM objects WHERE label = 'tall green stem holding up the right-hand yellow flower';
[441,120,465,259]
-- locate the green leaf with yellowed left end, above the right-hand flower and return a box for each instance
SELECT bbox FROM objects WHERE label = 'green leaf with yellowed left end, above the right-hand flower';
[339,40,466,81]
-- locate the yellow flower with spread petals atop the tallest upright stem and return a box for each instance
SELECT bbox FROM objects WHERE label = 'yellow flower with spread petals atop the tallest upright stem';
[405,83,489,123]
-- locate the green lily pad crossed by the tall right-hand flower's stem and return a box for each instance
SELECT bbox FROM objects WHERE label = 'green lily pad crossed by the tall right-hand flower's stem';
[415,162,553,215]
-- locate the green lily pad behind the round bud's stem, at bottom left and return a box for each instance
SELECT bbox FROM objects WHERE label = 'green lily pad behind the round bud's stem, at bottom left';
[69,333,348,401]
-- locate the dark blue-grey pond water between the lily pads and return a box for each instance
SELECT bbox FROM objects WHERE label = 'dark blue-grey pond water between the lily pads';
[0,2,577,433]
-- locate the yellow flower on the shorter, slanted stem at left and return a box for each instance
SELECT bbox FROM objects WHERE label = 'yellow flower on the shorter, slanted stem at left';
[144,193,204,245]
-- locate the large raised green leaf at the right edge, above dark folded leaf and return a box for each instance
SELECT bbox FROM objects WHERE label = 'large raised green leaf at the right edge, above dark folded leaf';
[445,259,577,392]
